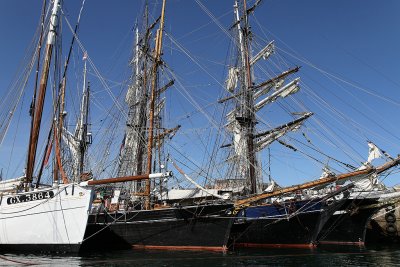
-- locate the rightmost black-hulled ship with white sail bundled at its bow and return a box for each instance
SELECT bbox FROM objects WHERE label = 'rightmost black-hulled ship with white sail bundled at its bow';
[312,142,400,246]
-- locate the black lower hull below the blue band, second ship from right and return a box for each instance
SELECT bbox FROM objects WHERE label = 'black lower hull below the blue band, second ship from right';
[232,201,344,248]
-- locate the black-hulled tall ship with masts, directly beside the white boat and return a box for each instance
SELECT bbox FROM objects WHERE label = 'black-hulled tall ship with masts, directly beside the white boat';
[86,0,233,251]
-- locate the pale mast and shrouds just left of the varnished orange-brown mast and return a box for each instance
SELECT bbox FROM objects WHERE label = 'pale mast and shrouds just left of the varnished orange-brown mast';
[117,5,154,194]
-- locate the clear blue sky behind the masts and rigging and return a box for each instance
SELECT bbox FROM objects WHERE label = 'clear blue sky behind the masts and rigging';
[0,0,400,188]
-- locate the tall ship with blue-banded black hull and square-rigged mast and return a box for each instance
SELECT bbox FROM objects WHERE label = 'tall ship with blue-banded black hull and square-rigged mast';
[208,1,349,247]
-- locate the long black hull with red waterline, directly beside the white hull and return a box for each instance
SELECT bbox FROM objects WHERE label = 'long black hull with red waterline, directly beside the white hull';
[85,204,234,251]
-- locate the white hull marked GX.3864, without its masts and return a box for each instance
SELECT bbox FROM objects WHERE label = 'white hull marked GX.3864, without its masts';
[0,184,92,253]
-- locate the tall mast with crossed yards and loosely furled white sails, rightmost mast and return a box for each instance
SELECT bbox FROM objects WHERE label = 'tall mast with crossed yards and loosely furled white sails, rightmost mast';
[223,0,304,197]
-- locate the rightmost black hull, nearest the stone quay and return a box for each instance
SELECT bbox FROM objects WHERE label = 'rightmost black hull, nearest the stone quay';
[318,199,380,246]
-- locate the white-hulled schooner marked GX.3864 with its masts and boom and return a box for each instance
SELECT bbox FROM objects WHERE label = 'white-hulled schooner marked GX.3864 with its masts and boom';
[0,0,172,252]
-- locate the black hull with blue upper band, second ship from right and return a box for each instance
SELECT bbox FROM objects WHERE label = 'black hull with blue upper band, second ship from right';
[232,199,343,248]
